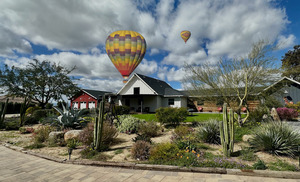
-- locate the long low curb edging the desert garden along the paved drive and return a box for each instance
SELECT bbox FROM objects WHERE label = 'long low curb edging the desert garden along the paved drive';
[0,143,300,179]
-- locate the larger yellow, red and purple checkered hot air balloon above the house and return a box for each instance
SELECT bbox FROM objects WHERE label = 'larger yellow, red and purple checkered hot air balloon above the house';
[105,30,147,83]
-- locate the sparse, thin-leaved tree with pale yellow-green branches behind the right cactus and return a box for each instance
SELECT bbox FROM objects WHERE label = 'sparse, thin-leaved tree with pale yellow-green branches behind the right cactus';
[184,41,278,125]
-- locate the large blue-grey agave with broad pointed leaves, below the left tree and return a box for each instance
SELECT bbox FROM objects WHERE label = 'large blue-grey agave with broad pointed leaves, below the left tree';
[54,105,84,128]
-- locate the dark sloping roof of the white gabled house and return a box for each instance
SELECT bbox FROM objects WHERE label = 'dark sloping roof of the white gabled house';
[135,73,184,96]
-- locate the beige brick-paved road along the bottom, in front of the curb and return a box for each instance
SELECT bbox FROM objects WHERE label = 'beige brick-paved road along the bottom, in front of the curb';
[0,146,300,182]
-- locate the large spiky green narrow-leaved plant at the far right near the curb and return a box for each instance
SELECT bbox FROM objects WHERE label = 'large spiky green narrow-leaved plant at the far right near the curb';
[249,122,300,157]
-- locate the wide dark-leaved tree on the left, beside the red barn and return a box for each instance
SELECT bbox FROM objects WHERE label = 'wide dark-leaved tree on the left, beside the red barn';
[0,59,78,108]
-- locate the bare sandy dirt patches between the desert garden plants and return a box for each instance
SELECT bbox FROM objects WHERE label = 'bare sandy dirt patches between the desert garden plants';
[0,125,299,169]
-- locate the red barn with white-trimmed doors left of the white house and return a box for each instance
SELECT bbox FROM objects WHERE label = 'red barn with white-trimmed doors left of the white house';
[70,89,111,109]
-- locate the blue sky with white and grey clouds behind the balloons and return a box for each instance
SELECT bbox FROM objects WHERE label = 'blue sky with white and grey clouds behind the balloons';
[0,0,300,91]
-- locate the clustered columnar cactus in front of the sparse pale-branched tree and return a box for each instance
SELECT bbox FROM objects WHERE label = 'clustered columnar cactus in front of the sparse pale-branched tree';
[220,103,234,157]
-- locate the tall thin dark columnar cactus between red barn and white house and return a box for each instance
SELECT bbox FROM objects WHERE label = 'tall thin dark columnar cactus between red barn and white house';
[94,96,105,151]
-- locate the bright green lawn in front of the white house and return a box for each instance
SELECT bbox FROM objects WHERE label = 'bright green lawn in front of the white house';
[132,113,223,122]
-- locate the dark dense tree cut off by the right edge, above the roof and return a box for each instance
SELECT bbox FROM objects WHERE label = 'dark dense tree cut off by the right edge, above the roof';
[281,45,300,81]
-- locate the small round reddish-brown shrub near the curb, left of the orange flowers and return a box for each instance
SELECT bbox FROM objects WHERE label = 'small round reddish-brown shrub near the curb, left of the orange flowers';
[131,140,151,161]
